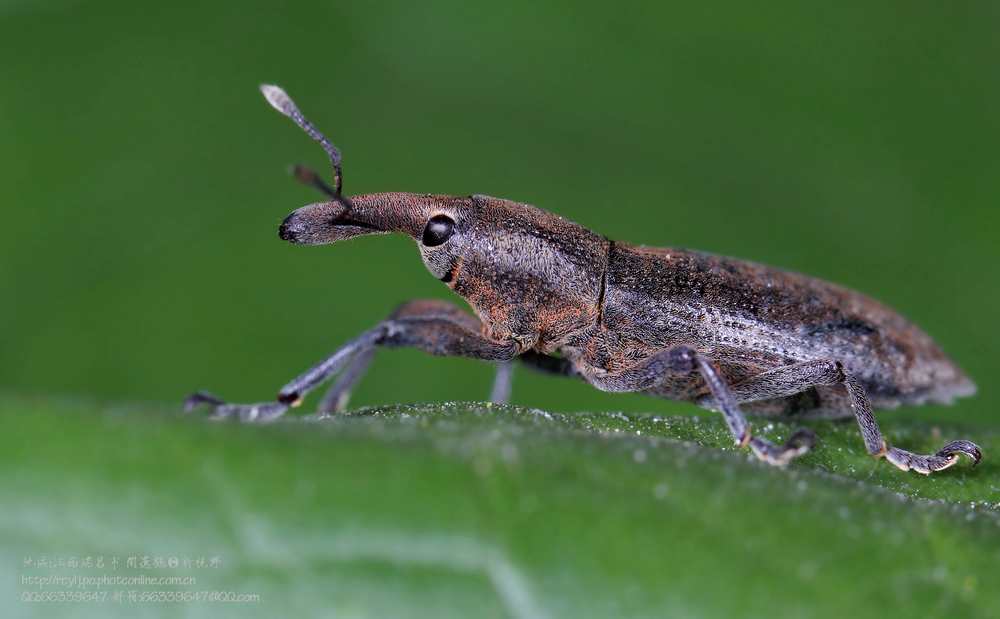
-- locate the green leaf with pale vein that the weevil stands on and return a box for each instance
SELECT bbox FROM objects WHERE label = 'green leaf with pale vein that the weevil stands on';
[0,395,1000,617]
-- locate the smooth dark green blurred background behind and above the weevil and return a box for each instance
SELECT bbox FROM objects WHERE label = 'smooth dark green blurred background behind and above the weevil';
[0,1,1000,422]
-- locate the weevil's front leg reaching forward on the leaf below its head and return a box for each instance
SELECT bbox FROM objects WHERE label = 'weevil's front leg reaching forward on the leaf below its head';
[184,301,519,421]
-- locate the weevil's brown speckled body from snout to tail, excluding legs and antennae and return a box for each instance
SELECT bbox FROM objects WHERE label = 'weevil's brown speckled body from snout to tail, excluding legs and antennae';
[300,194,975,417]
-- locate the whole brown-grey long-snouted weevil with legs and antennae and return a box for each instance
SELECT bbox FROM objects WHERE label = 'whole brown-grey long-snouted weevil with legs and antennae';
[185,86,981,474]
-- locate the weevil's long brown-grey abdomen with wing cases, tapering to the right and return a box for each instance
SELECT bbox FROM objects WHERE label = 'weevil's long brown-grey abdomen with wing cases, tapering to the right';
[584,243,975,416]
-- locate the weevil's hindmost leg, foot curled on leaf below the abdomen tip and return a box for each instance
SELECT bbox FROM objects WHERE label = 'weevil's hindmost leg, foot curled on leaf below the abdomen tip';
[712,359,982,475]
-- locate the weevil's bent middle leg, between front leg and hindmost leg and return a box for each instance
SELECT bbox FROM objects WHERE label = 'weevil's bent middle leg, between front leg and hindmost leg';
[589,344,814,465]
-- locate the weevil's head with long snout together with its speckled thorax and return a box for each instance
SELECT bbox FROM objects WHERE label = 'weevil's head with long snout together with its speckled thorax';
[279,193,609,350]
